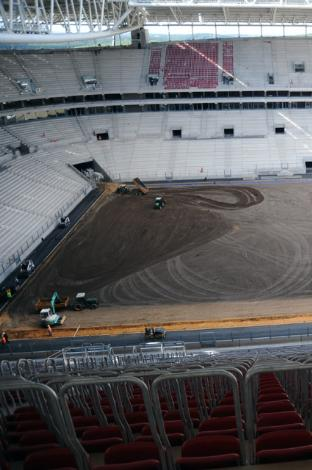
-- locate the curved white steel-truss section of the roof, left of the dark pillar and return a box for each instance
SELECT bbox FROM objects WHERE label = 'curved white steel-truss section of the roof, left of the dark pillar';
[0,0,145,43]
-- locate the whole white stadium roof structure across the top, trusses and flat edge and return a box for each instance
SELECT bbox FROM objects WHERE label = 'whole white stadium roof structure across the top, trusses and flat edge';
[0,0,312,44]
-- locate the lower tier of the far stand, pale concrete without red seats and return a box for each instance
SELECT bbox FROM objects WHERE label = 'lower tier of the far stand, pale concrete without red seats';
[0,109,312,181]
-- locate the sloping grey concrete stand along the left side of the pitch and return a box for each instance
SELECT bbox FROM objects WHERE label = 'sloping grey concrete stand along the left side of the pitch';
[0,152,92,277]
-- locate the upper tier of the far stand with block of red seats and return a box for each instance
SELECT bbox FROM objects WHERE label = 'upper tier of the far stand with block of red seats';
[0,38,312,97]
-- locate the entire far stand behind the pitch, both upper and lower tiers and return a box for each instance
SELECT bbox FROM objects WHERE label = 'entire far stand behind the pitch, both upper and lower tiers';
[4,39,312,191]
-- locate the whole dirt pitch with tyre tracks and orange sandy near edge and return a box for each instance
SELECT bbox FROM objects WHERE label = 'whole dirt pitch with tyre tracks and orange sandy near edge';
[2,182,312,334]
